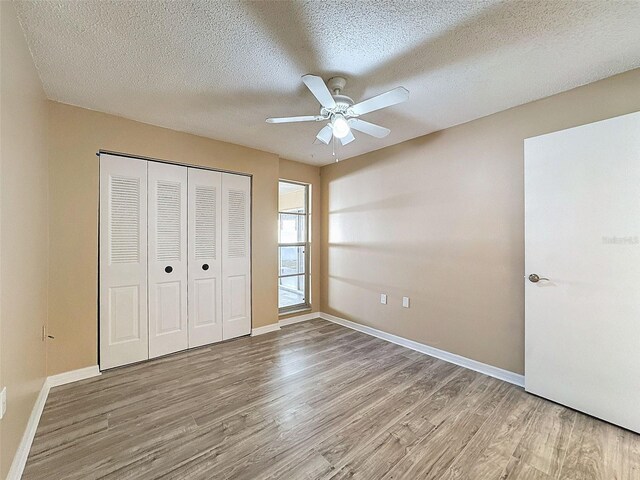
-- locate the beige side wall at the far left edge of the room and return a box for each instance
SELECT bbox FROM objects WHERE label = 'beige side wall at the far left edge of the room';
[0,2,48,478]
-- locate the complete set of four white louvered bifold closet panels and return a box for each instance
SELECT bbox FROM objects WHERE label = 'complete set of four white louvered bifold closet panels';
[100,154,251,369]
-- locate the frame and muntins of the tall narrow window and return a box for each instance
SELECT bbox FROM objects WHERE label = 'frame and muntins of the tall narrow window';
[278,178,311,315]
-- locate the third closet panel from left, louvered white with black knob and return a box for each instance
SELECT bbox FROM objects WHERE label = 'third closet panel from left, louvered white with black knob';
[188,168,222,347]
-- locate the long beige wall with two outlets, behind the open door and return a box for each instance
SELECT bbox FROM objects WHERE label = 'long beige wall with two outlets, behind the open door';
[321,69,640,373]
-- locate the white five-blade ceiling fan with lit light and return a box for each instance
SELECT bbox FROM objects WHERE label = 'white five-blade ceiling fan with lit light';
[266,75,409,145]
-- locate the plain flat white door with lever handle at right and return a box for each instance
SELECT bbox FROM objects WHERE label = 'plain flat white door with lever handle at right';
[525,112,640,432]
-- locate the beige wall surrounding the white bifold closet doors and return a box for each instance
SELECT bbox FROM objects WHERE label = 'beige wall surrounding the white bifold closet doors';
[47,102,279,375]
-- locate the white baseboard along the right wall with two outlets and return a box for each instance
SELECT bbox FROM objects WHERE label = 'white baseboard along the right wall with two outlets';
[320,313,524,387]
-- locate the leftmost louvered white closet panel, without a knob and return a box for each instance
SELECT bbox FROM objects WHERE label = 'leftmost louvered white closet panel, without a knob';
[99,154,149,369]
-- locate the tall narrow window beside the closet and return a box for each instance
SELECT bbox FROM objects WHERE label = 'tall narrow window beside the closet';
[278,181,310,313]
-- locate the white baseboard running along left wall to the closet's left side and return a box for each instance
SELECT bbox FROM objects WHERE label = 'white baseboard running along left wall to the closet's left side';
[7,365,101,480]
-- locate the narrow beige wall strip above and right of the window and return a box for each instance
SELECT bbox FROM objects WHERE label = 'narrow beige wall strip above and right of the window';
[280,159,322,318]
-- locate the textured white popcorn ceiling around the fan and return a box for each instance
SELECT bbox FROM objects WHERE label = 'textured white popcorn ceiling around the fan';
[16,0,640,165]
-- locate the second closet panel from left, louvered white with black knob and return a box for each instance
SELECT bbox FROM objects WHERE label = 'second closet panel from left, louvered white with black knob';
[148,162,189,358]
